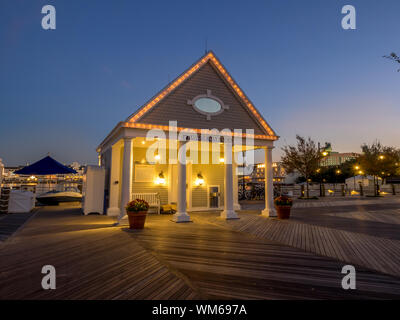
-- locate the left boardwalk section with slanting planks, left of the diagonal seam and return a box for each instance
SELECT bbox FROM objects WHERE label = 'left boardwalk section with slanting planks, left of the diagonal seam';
[0,207,198,299]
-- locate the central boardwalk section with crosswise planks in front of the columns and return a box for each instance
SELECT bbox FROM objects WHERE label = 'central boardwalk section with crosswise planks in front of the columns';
[131,213,400,299]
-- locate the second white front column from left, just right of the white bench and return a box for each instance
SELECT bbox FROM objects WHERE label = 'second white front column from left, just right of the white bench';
[172,142,190,222]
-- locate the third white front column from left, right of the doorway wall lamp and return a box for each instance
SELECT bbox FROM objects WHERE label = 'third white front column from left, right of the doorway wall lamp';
[221,140,238,219]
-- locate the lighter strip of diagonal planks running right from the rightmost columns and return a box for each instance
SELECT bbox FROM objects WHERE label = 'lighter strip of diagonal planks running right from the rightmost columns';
[200,211,400,276]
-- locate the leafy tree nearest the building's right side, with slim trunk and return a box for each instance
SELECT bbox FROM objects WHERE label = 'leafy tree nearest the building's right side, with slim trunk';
[281,135,322,198]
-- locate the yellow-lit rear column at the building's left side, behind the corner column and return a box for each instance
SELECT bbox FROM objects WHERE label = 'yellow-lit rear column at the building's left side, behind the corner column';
[107,142,121,216]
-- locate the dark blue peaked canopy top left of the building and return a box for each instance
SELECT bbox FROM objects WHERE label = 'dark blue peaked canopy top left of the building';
[14,156,76,176]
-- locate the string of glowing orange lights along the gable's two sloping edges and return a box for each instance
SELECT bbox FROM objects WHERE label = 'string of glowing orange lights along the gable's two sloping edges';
[129,52,278,140]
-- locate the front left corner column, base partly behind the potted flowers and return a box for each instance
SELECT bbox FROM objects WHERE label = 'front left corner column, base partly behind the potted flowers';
[118,138,132,220]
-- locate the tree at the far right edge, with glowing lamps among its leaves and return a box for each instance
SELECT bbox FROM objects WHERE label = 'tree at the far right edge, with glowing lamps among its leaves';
[358,141,400,196]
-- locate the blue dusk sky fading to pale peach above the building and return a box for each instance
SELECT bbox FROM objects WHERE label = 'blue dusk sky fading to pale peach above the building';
[0,0,400,166]
